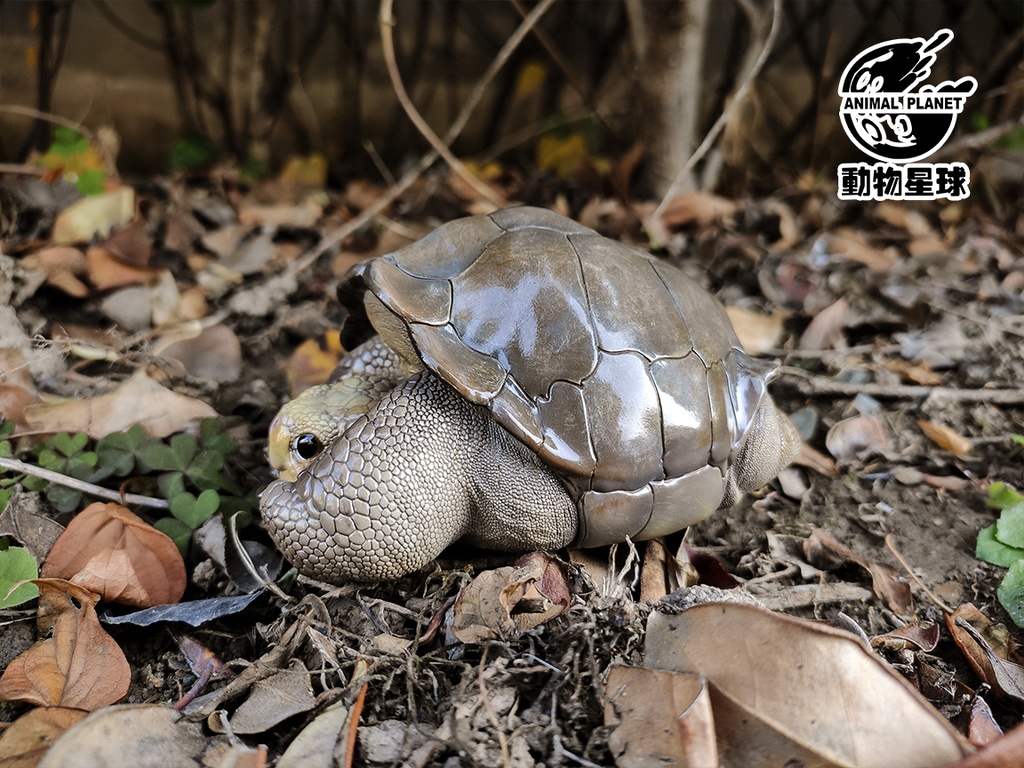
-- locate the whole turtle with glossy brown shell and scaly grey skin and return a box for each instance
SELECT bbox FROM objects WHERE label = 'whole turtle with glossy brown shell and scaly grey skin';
[260,207,800,584]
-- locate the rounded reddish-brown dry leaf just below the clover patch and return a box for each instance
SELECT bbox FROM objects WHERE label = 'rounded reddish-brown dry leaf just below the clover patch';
[43,502,188,608]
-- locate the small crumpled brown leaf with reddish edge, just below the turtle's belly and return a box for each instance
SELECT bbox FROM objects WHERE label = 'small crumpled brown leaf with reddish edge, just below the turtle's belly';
[452,552,571,643]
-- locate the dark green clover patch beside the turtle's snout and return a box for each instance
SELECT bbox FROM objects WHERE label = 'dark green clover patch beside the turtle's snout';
[0,419,255,551]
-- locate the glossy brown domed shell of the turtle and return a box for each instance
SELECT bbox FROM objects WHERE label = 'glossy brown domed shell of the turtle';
[342,208,767,546]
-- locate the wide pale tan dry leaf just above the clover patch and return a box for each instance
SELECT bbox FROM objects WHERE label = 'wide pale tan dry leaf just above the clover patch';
[25,371,217,439]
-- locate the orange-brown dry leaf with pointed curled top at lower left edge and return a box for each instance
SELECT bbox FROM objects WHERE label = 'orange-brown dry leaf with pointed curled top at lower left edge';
[0,579,131,711]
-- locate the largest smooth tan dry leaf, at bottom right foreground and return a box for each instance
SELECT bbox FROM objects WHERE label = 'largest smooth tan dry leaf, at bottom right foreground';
[644,603,969,768]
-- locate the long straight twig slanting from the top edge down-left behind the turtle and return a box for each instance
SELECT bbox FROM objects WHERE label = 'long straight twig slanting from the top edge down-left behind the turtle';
[287,0,554,274]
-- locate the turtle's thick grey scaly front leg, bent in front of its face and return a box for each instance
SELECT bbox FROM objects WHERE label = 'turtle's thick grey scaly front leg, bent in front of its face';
[260,372,577,583]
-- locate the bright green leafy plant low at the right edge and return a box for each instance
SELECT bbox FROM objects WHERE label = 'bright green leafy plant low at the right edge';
[975,442,1024,627]
